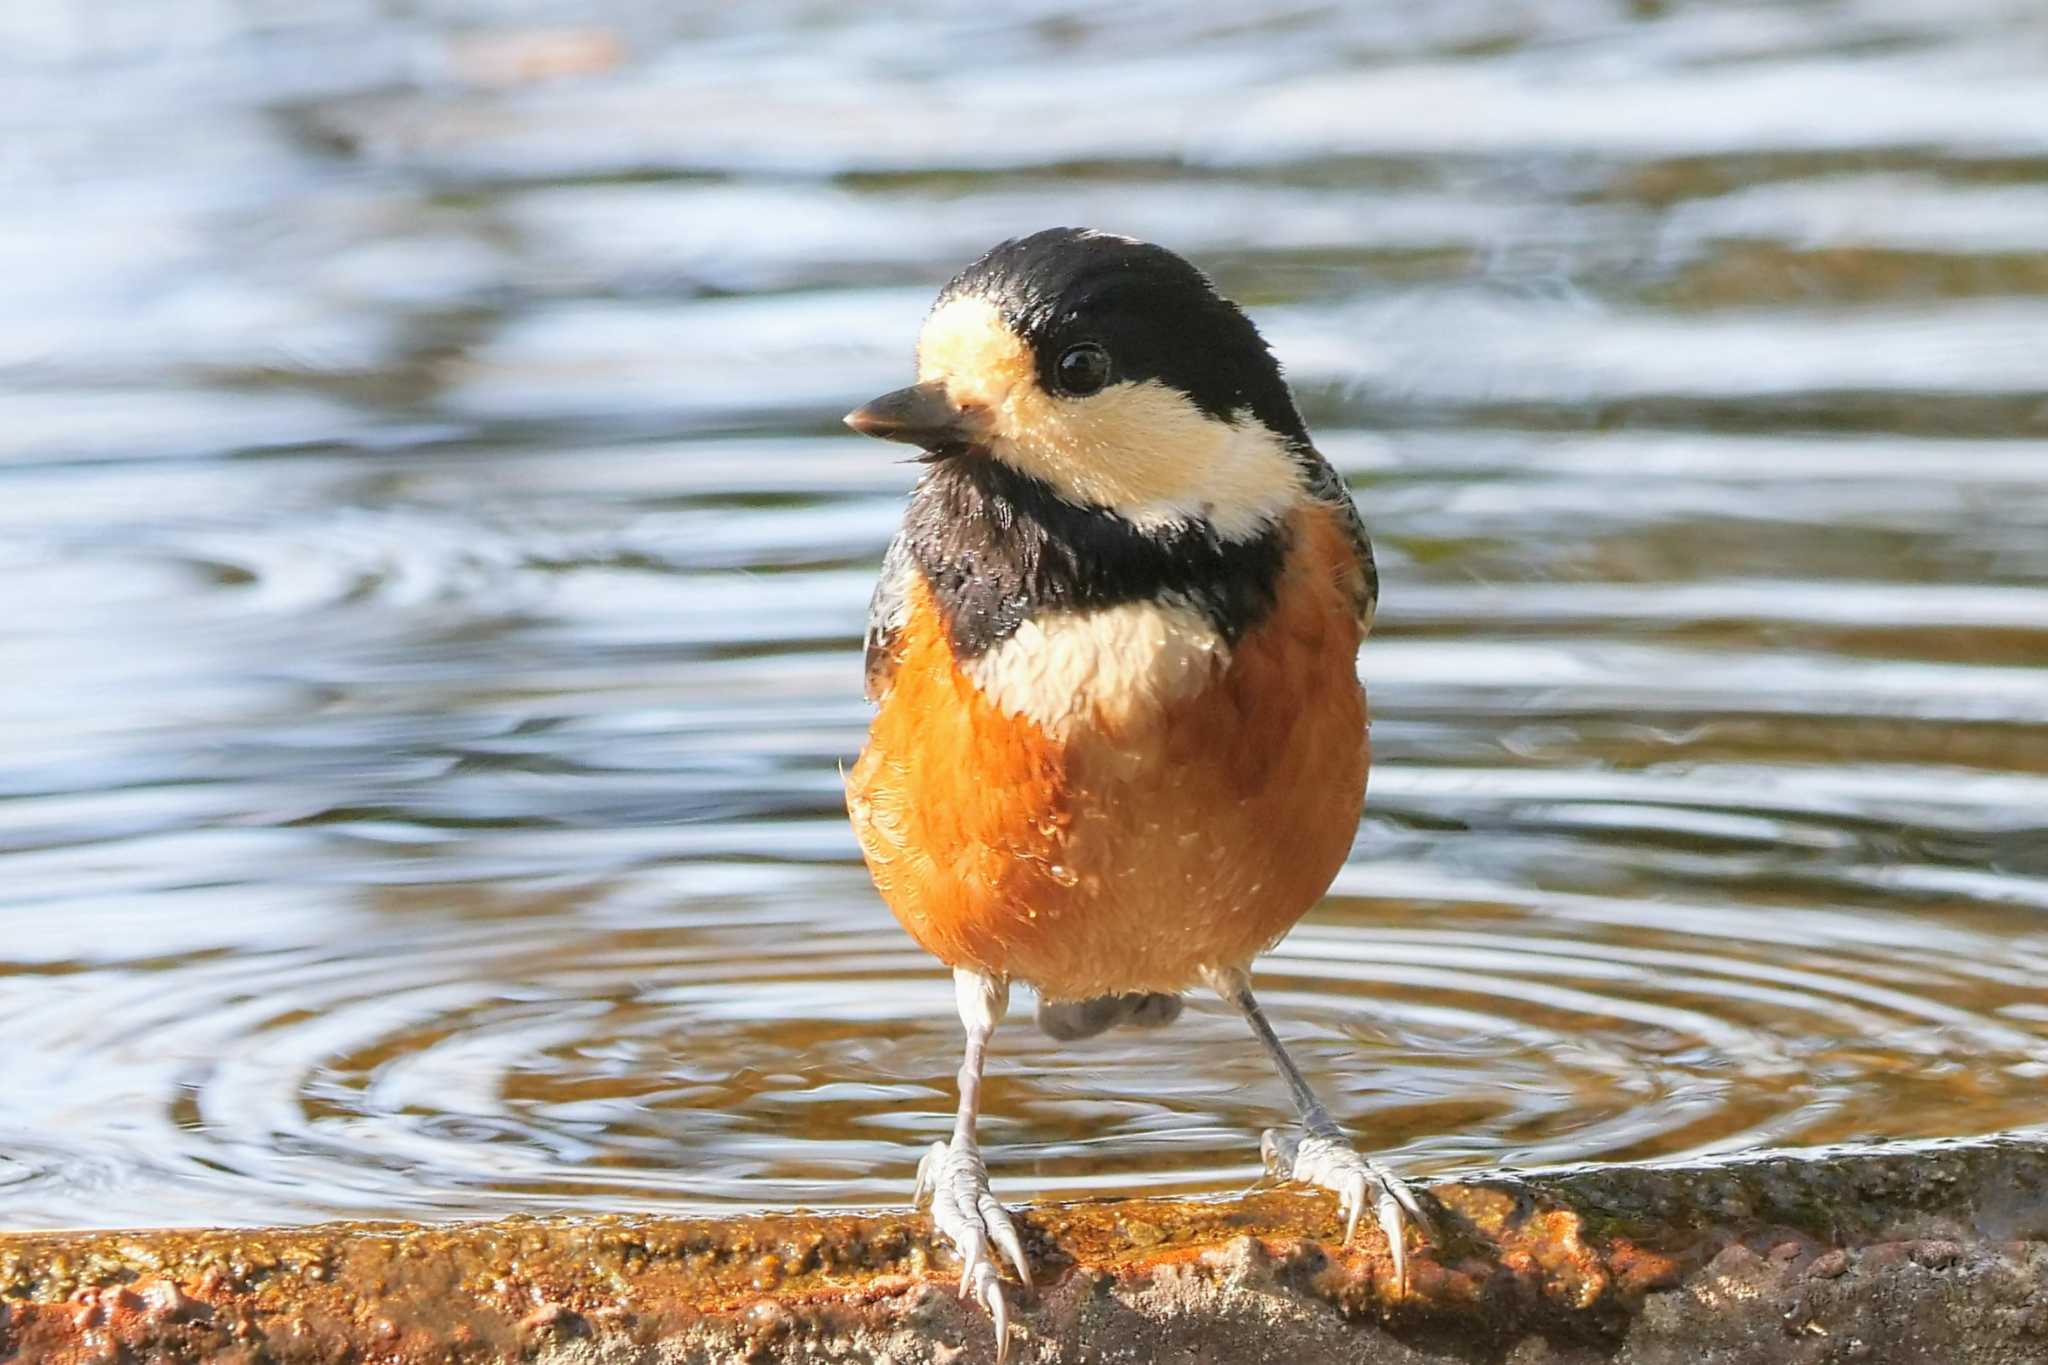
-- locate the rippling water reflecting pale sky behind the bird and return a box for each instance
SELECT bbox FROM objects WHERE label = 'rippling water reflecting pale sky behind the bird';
[0,0,2048,1226]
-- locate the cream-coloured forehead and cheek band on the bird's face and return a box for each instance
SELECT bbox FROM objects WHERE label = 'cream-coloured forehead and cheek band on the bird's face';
[918,297,1303,540]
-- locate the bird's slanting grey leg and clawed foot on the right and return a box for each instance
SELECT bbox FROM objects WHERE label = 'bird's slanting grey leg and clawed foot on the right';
[1208,968,1430,1291]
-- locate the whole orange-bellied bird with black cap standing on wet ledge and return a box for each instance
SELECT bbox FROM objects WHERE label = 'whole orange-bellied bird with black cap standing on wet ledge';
[846,227,1432,1359]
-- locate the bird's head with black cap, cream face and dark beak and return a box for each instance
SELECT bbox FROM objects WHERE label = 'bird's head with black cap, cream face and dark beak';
[846,227,1309,540]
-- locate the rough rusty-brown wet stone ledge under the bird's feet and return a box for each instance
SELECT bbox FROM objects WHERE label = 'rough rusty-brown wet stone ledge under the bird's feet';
[0,1138,2048,1365]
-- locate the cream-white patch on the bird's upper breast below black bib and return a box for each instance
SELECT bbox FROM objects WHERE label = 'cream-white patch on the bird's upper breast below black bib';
[965,600,1231,739]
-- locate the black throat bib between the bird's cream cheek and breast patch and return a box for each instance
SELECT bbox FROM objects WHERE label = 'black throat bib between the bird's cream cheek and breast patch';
[903,456,1286,659]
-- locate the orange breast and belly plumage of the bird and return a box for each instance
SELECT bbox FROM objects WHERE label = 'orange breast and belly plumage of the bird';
[848,510,1368,999]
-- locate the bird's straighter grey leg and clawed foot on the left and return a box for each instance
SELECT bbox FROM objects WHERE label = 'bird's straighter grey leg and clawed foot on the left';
[911,968,1030,1365]
